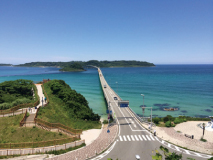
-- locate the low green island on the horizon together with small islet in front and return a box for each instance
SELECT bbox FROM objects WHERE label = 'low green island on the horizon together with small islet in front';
[16,60,155,71]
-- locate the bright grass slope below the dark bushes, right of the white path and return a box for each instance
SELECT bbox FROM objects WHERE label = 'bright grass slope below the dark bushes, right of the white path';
[38,84,101,130]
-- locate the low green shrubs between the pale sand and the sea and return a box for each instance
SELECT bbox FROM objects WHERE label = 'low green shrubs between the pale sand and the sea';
[153,115,209,127]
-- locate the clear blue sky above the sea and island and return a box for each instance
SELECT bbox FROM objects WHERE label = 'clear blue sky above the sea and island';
[0,0,213,64]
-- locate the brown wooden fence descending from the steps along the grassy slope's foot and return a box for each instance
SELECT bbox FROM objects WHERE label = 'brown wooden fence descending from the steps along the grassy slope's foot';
[34,118,82,138]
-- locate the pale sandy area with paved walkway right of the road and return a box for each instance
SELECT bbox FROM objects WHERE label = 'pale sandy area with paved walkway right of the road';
[143,121,213,154]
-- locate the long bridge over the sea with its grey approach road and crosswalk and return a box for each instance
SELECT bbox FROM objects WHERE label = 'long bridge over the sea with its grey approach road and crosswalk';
[93,66,211,160]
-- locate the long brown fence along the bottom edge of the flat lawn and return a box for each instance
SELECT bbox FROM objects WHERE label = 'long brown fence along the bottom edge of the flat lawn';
[0,137,77,149]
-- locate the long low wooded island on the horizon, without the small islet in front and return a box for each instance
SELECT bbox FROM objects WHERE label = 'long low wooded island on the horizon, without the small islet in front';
[16,60,155,68]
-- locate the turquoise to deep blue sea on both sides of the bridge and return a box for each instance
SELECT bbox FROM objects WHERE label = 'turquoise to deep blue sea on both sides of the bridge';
[0,65,213,117]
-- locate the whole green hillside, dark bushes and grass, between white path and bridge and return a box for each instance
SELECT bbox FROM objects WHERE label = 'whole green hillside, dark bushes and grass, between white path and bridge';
[38,80,101,130]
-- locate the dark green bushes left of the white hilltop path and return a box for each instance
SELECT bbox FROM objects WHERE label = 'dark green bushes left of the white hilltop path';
[0,79,35,110]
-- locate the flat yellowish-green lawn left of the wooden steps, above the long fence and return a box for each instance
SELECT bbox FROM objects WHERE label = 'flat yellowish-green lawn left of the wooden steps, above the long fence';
[0,114,68,143]
